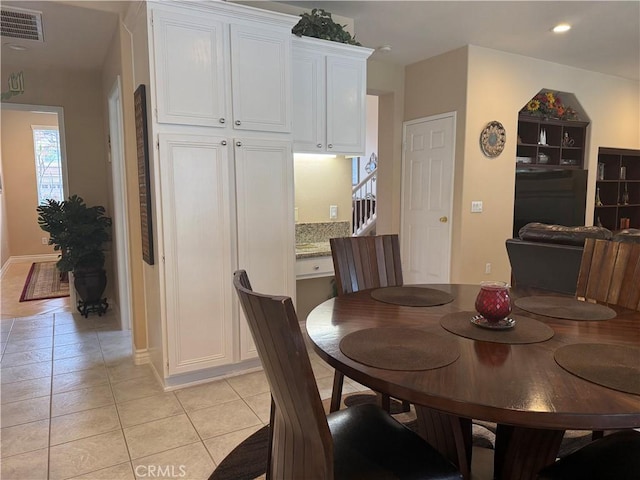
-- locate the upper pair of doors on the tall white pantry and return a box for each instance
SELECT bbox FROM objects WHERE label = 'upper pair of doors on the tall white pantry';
[153,8,292,132]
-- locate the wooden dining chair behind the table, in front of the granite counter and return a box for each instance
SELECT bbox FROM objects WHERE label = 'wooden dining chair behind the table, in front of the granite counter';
[329,234,409,412]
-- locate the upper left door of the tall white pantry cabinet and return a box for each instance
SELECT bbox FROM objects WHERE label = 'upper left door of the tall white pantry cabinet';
[153,12,228,127]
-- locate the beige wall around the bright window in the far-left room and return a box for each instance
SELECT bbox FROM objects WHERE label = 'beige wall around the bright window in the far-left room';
[2,108,58,263]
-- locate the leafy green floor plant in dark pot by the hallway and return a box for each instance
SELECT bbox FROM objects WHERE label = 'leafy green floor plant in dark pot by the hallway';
[36,195,111,317]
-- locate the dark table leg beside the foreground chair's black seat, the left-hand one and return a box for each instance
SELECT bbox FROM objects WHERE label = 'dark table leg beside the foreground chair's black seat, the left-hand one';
[415,405,472,480]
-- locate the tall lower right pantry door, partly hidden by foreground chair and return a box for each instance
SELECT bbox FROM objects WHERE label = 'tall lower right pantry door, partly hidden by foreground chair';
[235,139,296,360]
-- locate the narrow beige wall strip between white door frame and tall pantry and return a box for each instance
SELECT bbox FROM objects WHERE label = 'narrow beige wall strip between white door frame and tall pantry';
[102,19,147,351]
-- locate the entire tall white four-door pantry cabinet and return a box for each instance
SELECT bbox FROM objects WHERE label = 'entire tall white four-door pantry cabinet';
[125,1,299,387]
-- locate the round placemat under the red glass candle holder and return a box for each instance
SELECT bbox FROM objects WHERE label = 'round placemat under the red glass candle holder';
[440,312,554,344]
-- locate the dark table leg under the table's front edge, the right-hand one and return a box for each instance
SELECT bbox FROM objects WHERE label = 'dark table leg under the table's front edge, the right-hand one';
[493,424,564,480]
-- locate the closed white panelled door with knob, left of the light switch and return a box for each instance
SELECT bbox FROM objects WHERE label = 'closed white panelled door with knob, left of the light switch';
[400,113,456,284]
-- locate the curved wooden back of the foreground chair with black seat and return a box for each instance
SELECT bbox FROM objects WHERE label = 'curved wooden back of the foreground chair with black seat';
[233,270,333,480]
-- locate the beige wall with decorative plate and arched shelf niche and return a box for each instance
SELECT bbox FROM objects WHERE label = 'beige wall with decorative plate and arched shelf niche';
[398,46,640,283]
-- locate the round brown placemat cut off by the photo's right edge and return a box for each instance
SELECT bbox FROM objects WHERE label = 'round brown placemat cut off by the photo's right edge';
[553,343,640,395]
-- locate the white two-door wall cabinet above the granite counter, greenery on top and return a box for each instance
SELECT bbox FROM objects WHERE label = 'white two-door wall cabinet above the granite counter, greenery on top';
[293,37,373,155]
